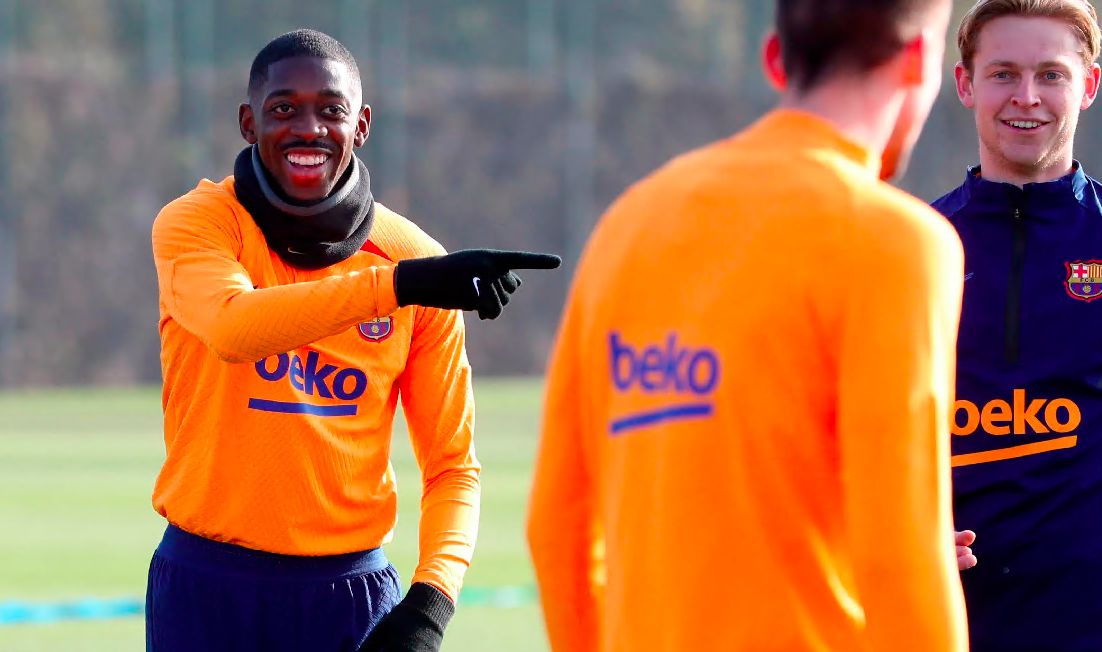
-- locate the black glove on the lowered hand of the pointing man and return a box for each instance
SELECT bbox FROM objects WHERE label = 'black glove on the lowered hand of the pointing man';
[359,582,455,652]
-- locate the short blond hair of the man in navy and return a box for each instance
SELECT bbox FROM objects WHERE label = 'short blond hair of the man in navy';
[957,0,1102,70]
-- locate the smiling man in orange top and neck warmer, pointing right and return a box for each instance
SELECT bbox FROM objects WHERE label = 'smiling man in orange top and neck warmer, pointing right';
[147,30,559,652]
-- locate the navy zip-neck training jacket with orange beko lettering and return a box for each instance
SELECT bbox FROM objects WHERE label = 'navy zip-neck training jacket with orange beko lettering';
[933,162,1102,652]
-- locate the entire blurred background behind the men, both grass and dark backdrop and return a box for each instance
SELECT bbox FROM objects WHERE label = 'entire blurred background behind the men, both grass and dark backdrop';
[0,0,1102,651]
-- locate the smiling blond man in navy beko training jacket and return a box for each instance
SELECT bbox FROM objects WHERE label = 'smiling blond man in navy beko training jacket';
[933,0,1102,652]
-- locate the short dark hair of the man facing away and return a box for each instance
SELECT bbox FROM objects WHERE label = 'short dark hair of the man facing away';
[776,0,944,91]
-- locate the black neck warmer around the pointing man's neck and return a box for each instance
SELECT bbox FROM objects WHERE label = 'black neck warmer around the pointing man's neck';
[234,145,375,270]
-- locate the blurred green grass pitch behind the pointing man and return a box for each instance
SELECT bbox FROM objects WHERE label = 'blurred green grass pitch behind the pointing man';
[0,379,547,652]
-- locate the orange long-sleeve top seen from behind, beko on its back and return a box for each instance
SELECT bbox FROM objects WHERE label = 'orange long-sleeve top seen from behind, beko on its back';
[528,110,966,652]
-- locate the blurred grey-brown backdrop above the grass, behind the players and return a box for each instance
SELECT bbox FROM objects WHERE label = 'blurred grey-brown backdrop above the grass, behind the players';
[0,0,1098,385]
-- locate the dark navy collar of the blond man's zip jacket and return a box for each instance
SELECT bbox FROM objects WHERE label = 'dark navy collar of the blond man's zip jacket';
[961,161,1089,217]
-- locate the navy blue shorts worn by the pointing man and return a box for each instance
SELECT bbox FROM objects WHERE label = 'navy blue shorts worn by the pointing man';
[145,525,402,652]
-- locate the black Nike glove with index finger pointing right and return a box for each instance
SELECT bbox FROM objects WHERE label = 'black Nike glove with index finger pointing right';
[395,249,562,319]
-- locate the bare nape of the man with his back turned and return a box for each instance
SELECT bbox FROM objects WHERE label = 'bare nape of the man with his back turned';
[780,77,903,164]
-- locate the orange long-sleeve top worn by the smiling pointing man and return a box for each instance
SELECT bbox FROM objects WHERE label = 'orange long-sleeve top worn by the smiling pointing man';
[153,177,479,600]
